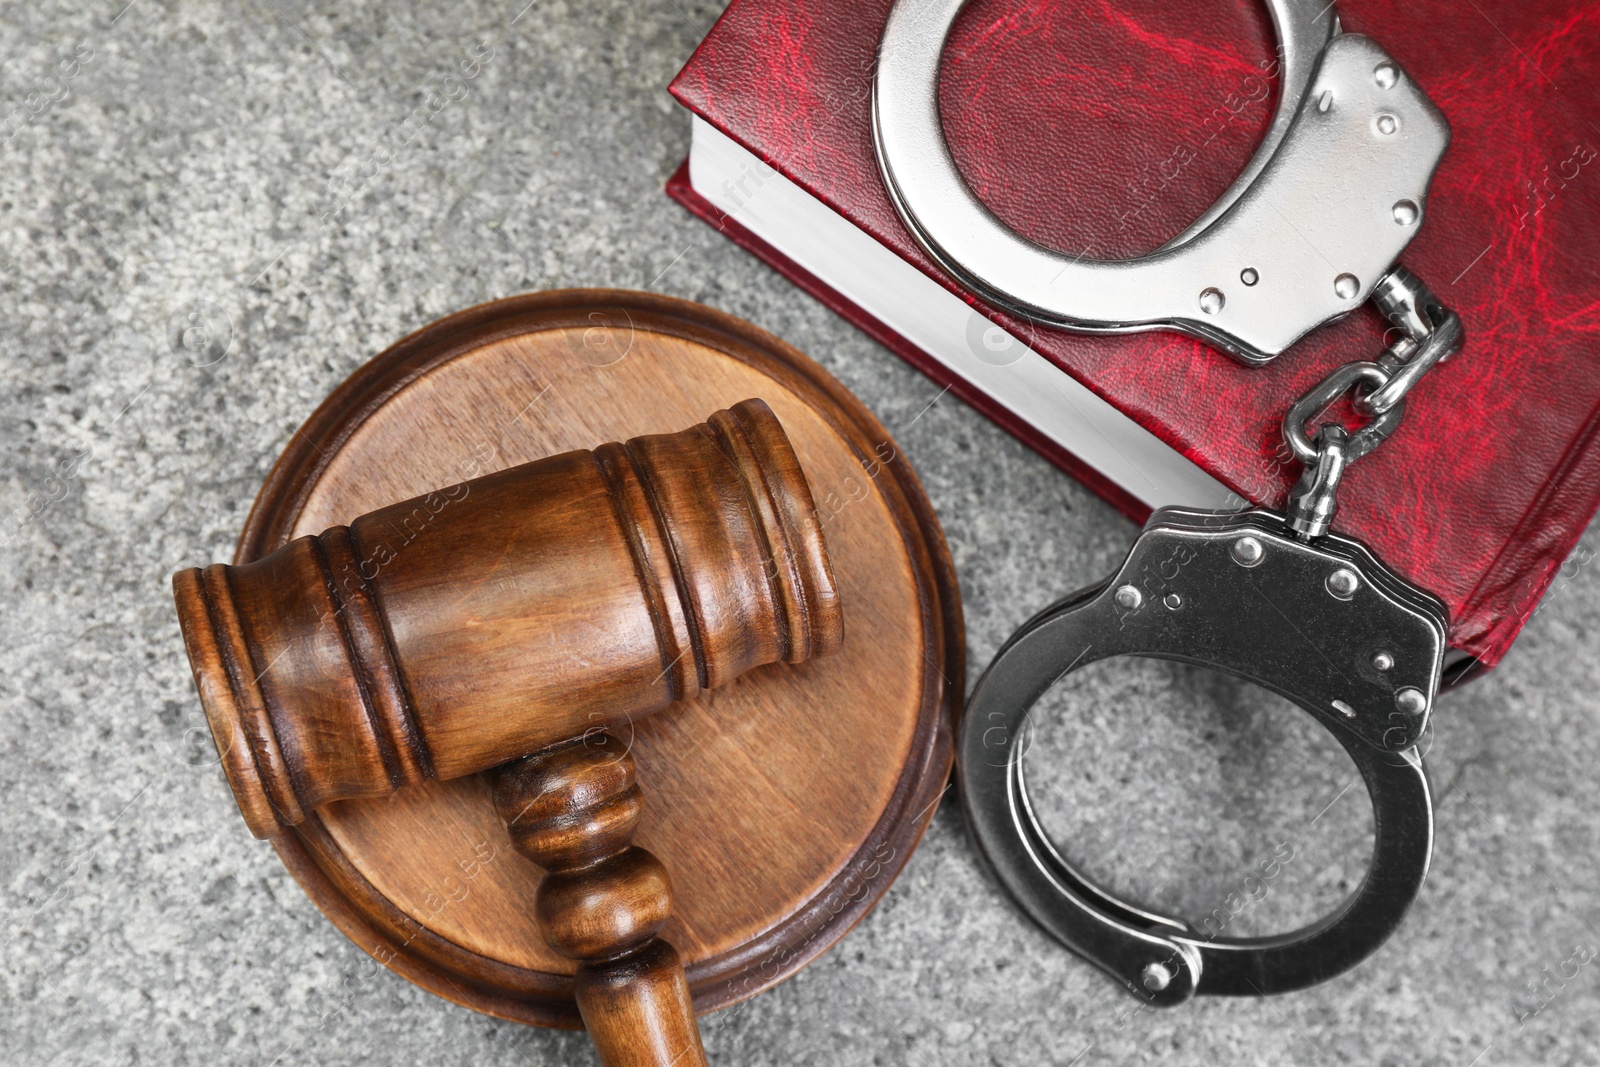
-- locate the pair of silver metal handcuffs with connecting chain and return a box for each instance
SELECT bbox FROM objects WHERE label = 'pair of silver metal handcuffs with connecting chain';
[872,0,1462,1005]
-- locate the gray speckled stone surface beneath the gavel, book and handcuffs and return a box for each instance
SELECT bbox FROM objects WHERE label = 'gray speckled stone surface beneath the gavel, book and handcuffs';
[0,0,1600,1067]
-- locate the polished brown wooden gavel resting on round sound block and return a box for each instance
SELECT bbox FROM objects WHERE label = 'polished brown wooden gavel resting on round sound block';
[173,400,843,1067]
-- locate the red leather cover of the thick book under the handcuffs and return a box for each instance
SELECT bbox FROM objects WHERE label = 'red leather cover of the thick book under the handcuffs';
[672,0,1600,665]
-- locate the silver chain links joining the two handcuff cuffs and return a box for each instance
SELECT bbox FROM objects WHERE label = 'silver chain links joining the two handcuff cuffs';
[1283,266,1464,541]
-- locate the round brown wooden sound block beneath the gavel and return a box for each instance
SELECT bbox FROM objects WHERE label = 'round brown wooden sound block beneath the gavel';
[235,290,965,1027]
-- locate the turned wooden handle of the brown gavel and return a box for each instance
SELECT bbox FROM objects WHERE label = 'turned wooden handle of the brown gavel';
[494,733,706,1067]
